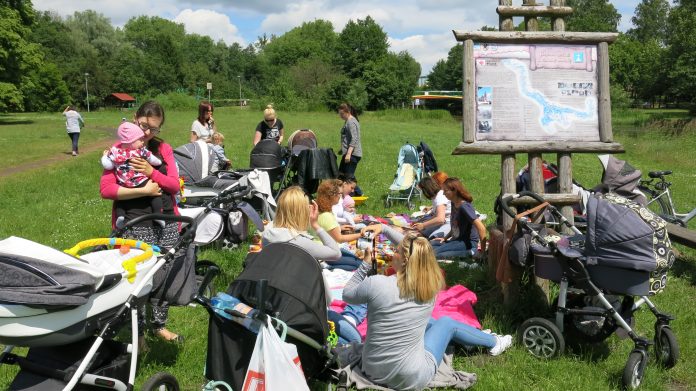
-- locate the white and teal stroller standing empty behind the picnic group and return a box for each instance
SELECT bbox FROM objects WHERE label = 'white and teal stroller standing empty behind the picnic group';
[384,143,423,209]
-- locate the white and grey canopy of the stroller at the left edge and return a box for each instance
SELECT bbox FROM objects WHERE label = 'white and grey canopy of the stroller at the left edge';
[0,236,104,308]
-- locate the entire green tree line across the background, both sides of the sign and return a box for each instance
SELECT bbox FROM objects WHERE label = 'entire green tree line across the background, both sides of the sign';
[0,0,696,112]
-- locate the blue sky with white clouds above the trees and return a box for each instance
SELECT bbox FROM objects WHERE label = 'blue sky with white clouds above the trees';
[32,0,639,76]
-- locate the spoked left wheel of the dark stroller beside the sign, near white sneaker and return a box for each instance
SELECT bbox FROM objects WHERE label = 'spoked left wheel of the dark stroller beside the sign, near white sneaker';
[519,318,565,359]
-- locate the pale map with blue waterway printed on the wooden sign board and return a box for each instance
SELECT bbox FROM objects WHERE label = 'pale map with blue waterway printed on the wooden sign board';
[474,43,599,141]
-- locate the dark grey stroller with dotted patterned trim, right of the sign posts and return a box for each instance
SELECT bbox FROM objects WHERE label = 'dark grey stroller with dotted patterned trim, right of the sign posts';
[502,192,679,389]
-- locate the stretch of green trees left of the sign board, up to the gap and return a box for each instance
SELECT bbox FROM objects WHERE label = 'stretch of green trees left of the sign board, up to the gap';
[0,0,421,112]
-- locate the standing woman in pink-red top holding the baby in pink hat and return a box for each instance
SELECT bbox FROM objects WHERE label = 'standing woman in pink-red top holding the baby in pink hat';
[99,101,183,350]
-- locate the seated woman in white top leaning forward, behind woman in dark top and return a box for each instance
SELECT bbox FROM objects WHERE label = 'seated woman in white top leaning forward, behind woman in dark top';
[411,177,452,239]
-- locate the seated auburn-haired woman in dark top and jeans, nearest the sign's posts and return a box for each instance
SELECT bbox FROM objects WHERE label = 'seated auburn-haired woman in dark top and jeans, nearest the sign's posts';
[430,178,486,259]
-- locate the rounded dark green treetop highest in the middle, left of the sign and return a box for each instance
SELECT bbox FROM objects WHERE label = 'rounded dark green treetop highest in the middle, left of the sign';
[335,16,389,77]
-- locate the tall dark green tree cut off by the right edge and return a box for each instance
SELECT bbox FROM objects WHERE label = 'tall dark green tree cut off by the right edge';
[665,0,696,112]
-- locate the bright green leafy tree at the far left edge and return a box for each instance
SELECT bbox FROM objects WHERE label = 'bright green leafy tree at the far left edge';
[0,0,43,112]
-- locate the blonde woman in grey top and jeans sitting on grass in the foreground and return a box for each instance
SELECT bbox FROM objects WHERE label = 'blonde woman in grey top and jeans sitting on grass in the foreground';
[343,225,512,390]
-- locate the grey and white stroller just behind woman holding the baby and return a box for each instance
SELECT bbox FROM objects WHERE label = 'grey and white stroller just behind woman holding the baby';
[174,140,275,220]
